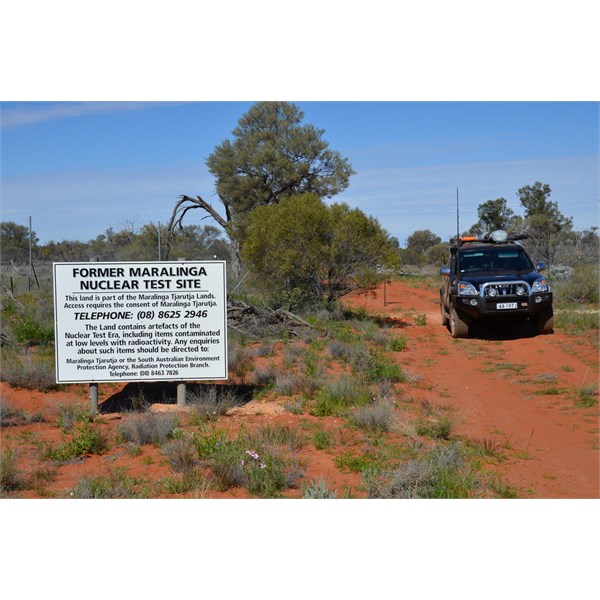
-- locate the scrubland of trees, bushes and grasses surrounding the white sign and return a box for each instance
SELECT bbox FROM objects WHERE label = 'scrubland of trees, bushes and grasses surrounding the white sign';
[0,102,598,499]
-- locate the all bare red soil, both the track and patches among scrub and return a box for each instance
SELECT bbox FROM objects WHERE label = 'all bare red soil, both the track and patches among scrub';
[0,281,600,499]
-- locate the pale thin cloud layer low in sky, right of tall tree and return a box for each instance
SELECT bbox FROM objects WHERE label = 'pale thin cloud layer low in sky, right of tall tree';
[341,157,598,242]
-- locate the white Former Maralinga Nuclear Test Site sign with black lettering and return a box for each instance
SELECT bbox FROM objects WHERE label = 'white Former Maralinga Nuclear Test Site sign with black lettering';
[54,261,228,396]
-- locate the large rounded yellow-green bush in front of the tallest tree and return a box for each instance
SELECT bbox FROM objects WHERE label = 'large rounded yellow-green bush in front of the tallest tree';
[242,193,398,306]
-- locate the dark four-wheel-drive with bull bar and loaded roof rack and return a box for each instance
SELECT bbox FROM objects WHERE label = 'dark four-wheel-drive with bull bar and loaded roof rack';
[440,231,553,338]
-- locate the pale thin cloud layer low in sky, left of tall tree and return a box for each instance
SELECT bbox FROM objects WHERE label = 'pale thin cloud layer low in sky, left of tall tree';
[2,162,220,243]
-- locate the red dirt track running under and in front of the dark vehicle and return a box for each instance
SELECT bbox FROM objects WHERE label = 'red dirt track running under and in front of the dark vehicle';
[352,281,600,499]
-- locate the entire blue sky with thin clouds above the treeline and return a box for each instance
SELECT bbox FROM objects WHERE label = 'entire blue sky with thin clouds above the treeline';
[1,101,599,244]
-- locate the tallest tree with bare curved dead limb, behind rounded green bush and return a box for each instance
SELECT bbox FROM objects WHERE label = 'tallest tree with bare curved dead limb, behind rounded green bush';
[169,102,354,268]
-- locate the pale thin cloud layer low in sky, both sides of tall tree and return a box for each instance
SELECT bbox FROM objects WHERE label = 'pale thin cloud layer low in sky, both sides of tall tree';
[2,157,598,243]
